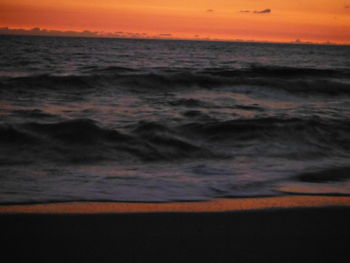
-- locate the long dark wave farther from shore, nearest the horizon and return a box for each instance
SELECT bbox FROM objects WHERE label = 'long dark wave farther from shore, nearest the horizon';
[0,66,350,96]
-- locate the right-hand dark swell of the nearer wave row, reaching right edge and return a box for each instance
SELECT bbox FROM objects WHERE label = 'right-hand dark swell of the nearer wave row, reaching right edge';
[178,118,350,155]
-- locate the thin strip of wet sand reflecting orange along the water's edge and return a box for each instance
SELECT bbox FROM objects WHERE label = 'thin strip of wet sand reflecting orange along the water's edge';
[0,195,350,214]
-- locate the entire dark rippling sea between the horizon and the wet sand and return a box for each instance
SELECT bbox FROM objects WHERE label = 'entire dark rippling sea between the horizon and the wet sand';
[0,36,350,203]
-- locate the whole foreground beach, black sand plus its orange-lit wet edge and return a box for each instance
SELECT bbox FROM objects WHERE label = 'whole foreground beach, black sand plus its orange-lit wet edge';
[0,197,350,262]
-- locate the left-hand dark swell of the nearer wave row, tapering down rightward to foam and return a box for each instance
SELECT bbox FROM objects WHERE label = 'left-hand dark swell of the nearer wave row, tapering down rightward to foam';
[0,119,213,163]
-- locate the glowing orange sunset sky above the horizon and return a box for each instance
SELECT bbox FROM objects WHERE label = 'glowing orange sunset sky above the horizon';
[0,0,350,44]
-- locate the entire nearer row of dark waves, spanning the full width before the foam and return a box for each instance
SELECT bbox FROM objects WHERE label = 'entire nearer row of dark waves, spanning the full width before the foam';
[0,118,350,163]
